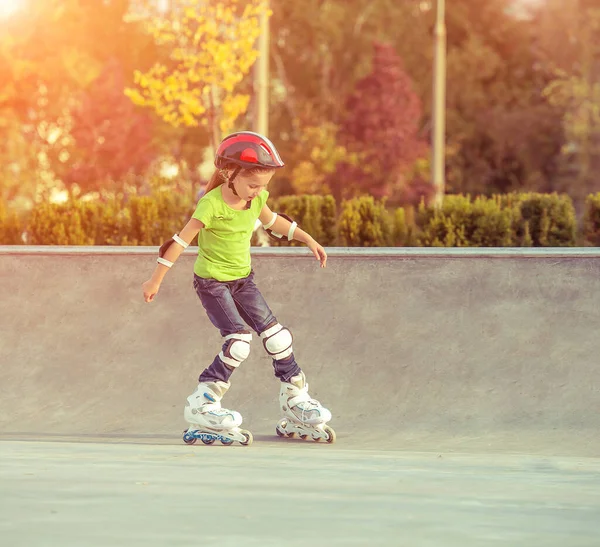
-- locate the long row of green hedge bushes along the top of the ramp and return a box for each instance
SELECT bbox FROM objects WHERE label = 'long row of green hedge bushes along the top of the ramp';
[0,192,600,247]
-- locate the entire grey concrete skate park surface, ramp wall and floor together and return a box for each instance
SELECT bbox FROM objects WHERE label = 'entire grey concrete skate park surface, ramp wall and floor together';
[0,248,600,547]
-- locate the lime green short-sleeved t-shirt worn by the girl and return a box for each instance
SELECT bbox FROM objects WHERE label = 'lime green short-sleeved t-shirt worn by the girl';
[192,186,269,281]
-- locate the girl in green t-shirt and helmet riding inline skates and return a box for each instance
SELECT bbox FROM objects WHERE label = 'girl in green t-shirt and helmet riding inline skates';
[142,131,335,444]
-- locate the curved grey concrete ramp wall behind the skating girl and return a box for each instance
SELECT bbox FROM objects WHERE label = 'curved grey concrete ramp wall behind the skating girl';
[0,247,600,456]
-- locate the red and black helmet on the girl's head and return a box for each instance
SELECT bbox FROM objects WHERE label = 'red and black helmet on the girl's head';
[215,131,285,169]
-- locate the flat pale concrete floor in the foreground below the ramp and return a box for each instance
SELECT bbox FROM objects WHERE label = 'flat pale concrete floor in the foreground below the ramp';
[0,435,600,547]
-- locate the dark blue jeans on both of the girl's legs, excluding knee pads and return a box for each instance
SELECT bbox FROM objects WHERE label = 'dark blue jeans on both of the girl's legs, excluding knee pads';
[194,271,301,382]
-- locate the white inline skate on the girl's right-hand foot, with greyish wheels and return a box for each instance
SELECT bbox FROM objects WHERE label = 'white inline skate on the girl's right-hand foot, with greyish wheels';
[276,372,335,443]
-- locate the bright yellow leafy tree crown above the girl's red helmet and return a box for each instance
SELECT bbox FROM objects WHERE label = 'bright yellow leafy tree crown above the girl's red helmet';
[125,0,270,150]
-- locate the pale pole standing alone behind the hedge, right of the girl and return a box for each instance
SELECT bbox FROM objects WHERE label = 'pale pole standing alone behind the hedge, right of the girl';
[431,0,446,207]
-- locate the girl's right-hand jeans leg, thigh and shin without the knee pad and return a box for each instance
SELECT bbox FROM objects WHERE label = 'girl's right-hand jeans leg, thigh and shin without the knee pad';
[231,272,301,382]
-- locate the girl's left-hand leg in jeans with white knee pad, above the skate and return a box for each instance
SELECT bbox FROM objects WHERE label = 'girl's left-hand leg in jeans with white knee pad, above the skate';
[194,276,252,382]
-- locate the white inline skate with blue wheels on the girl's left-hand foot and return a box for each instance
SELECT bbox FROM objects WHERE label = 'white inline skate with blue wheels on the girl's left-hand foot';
[183,382,252,445]
